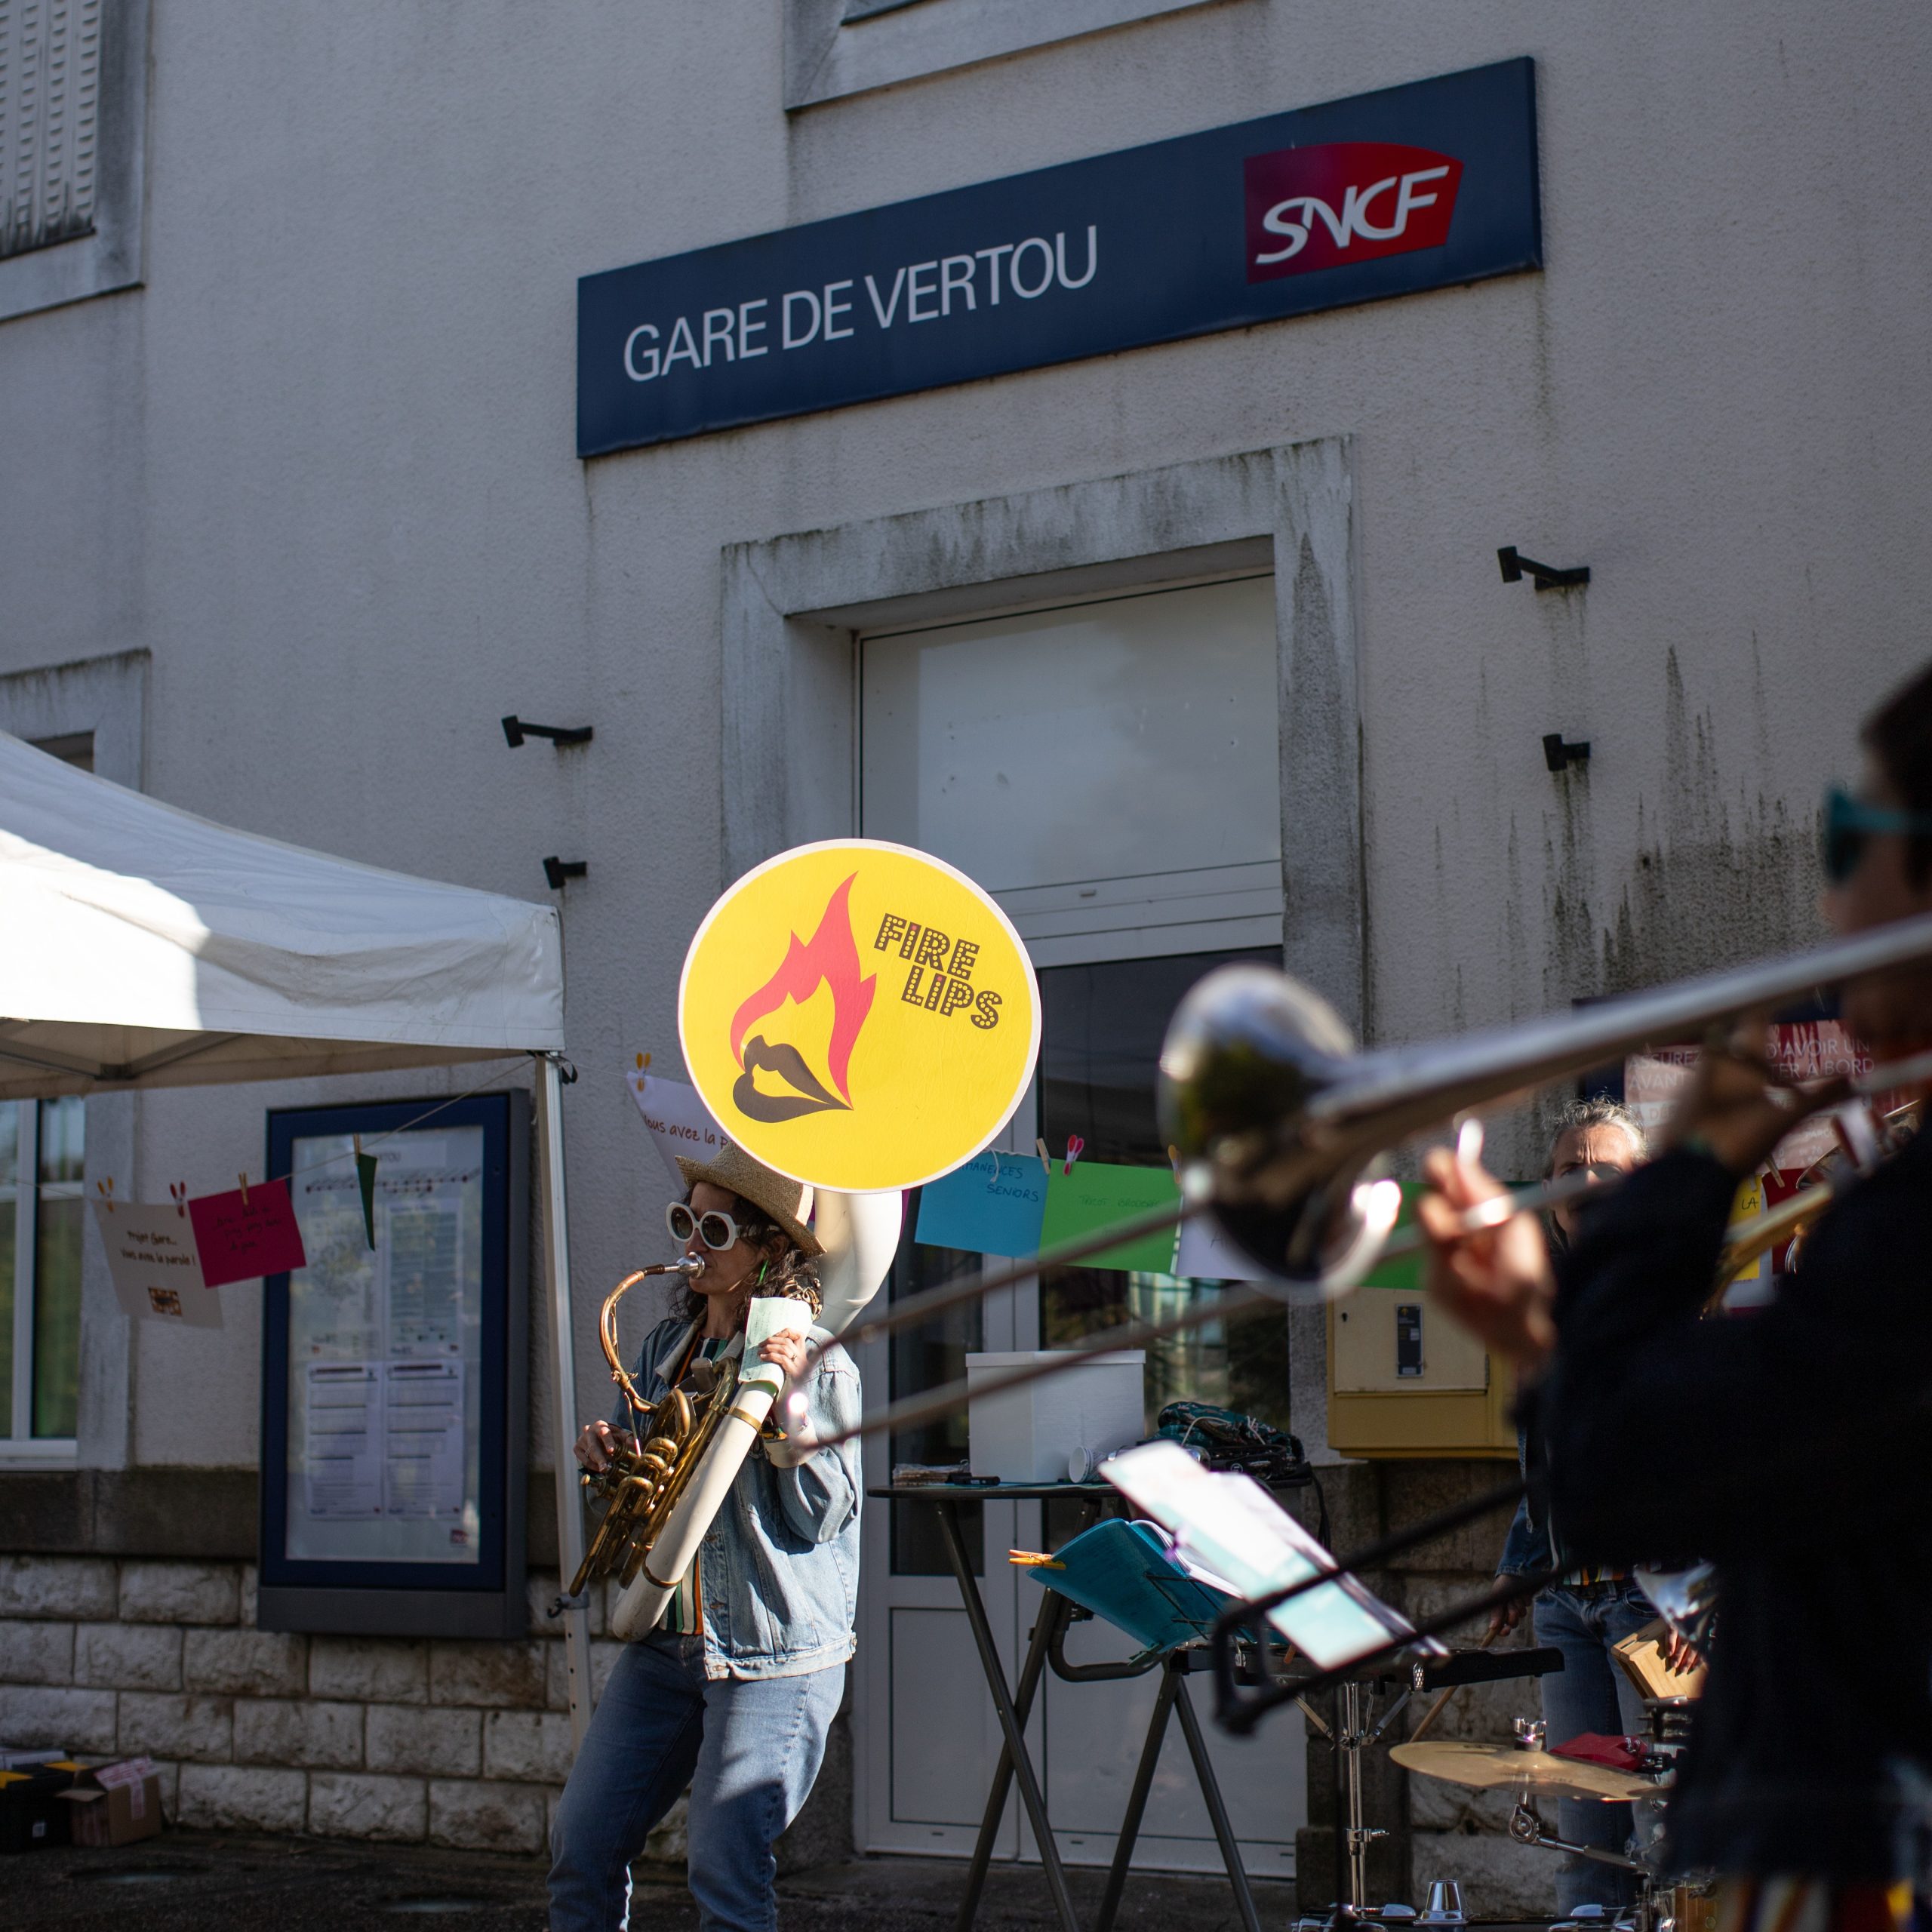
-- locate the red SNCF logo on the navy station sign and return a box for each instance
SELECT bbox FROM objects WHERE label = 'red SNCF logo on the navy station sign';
[1242,141,1463,282]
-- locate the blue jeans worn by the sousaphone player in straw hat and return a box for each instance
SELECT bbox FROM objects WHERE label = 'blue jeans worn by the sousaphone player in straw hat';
[551,1636,844,1932]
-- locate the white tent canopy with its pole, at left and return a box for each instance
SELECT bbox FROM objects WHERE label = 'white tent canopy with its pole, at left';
[0,732,589,1743]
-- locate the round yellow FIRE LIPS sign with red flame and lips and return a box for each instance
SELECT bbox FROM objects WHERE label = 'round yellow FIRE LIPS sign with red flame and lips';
[678,838,1039,1194]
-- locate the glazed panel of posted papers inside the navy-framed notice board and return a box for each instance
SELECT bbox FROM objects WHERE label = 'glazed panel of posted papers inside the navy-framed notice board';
[286,1126,485,1563]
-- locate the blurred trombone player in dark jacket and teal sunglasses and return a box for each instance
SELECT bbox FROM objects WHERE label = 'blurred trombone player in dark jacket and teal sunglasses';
[1418,669,1932,1932]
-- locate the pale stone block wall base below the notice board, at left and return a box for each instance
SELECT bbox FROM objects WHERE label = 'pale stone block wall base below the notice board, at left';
[0,1555,637,1853]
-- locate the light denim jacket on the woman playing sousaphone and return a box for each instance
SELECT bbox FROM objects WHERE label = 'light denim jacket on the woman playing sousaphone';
[638,1315,866,1677]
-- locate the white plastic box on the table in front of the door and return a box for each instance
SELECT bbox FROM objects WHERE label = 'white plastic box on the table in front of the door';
[966,1349,1148,1482]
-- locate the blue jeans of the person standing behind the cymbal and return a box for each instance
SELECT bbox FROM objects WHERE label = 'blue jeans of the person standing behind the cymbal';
[1534,1580,1657,1912]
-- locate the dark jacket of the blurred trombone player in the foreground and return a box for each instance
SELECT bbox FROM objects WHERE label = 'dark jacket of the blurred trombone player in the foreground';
[1536,1134,1932,1880]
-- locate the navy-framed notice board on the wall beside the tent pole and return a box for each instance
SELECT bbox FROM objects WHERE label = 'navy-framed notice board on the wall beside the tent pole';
[259,1094,529,1636]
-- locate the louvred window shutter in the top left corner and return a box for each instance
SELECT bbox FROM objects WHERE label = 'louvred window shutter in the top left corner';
[0,0,103,257]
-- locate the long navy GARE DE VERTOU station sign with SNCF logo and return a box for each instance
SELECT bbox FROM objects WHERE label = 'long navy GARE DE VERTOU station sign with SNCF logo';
[577,60,1542,456]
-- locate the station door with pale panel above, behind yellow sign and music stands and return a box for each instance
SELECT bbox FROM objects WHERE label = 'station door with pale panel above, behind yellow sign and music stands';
[856,576,1306,1878]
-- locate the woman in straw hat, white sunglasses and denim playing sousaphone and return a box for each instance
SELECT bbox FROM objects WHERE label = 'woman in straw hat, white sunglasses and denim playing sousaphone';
[551,1148,863,1932]
